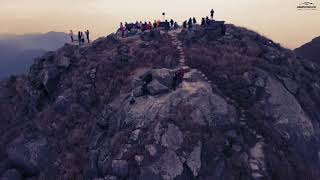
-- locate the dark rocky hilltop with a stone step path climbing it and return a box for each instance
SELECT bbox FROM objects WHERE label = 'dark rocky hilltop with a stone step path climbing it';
[0,24,320,180]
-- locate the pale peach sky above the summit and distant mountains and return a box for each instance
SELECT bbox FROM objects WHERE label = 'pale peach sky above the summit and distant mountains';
[0,0,320,48]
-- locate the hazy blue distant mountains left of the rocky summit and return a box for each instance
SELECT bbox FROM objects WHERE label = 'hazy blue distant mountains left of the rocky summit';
[0,32,69,78]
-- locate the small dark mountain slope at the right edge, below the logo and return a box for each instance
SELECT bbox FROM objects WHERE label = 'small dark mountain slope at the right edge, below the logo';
[294,36,320,63]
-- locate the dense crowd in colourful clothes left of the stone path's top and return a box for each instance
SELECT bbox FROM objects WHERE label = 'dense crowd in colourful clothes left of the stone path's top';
[118,19,179,37]
